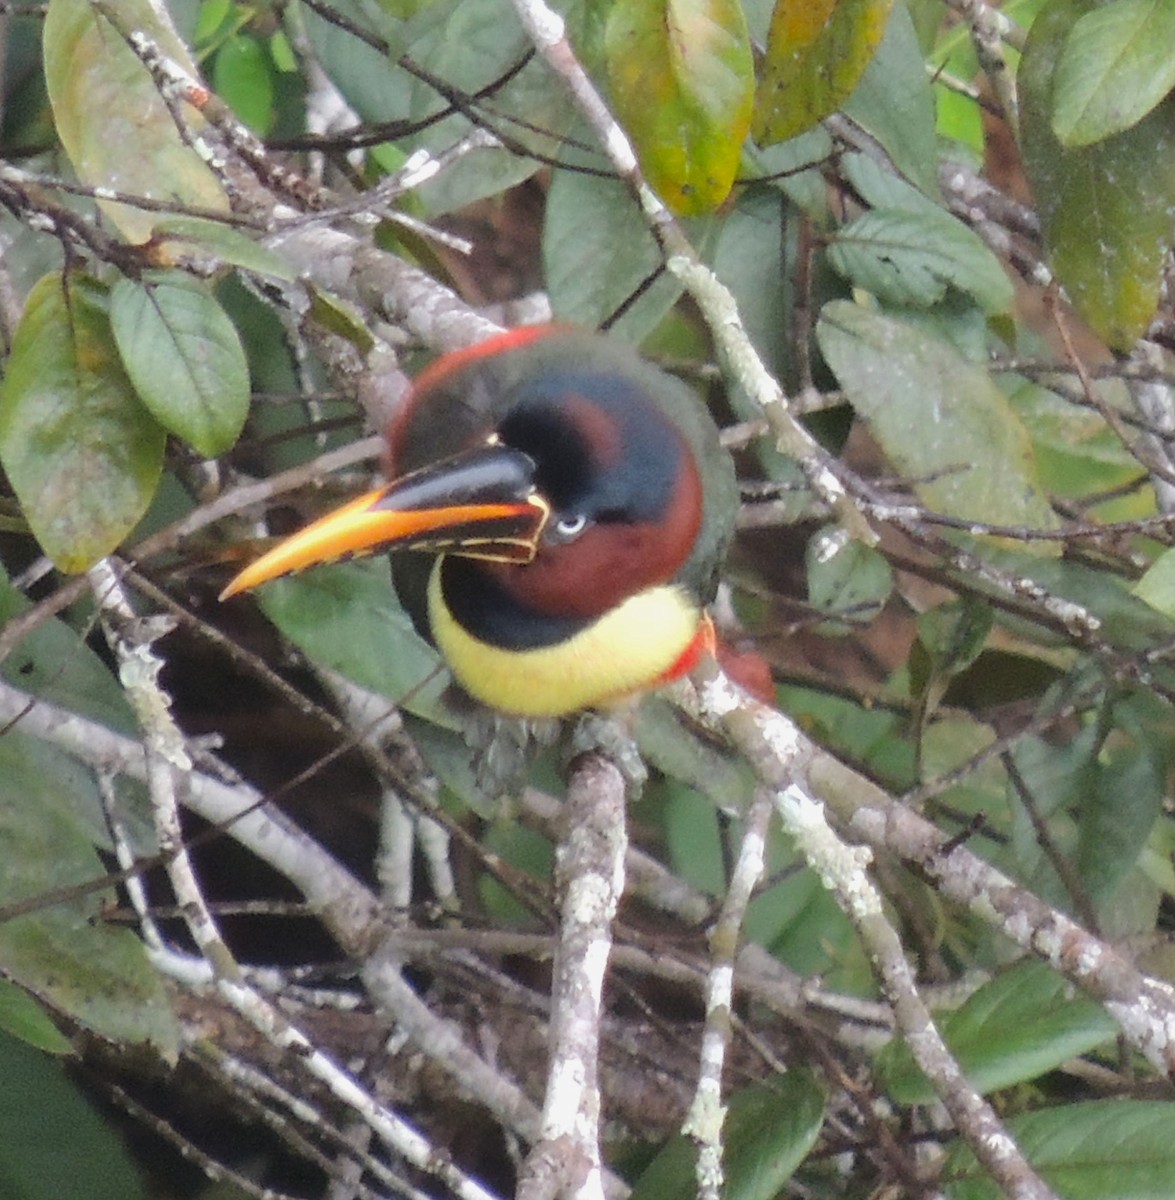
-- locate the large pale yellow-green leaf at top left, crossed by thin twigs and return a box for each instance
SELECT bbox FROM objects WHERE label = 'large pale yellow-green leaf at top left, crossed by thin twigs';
[43,0,228,242]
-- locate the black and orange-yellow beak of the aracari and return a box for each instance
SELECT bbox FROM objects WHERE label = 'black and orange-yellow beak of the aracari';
[221,439,551,600]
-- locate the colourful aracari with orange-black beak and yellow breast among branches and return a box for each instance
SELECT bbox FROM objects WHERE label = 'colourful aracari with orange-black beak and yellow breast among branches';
[222,325,738,718]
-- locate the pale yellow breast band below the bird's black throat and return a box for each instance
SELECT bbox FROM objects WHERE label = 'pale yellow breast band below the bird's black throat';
[428,559,701,716]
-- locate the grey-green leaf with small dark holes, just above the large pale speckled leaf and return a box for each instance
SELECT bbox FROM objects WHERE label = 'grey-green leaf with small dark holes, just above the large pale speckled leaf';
[828,204,1013,313]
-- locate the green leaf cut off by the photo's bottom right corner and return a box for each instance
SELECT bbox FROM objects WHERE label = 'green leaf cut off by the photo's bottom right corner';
[942,1100,1175,1200]
